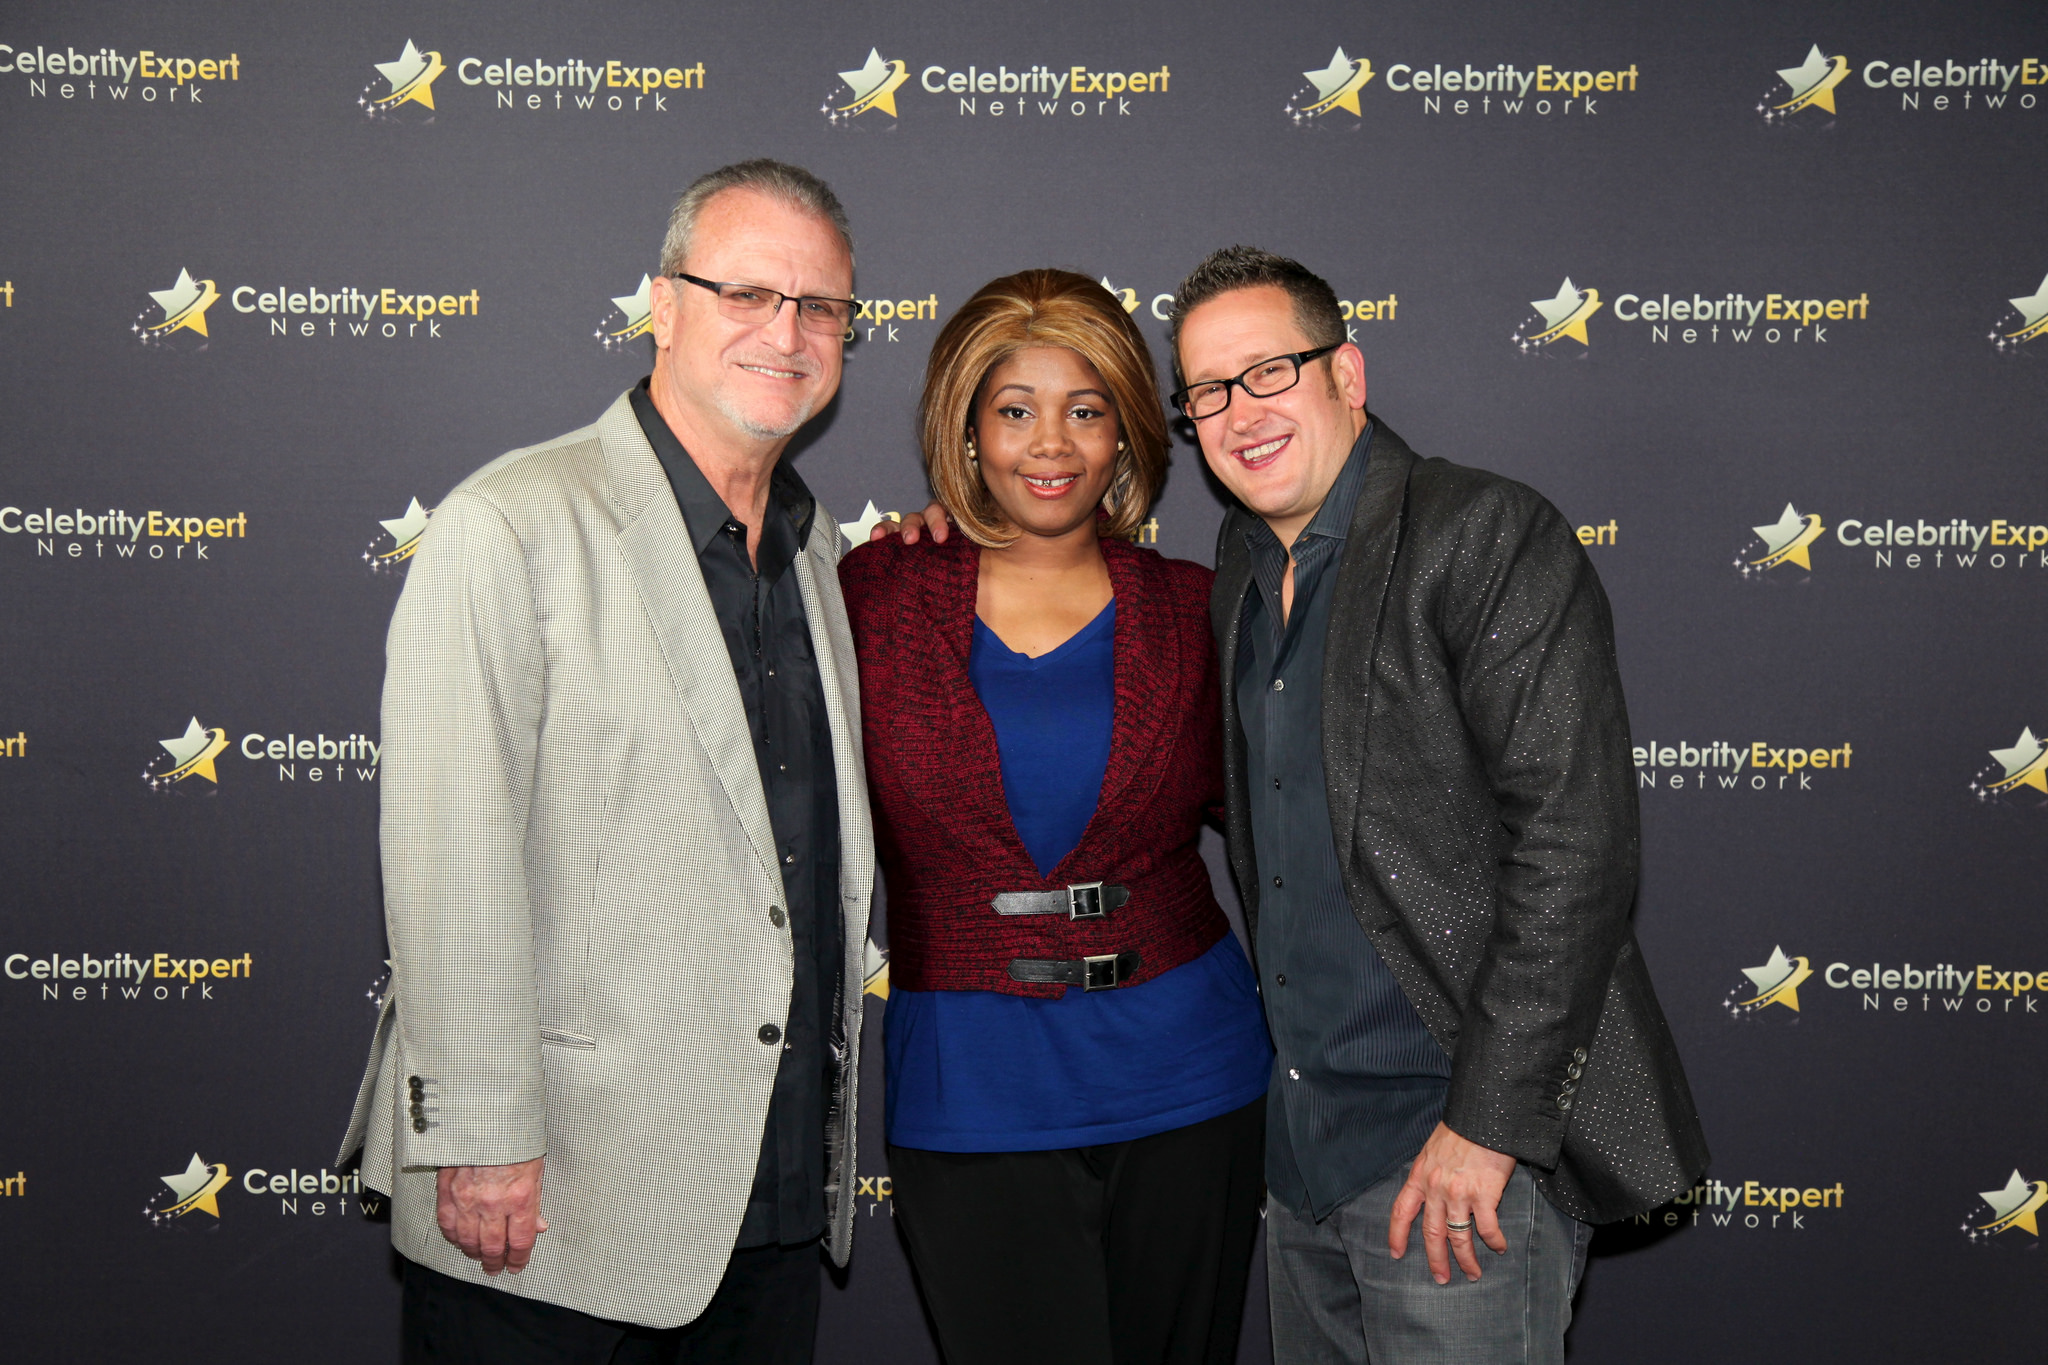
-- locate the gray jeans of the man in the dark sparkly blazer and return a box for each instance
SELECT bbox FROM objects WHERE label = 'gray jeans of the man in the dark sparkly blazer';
[1266,1166,1593,1365]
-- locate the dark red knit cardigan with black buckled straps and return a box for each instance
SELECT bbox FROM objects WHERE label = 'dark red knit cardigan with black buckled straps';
[840,534,1229,997]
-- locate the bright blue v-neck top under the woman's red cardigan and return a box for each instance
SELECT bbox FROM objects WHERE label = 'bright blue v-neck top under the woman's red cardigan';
[885,602,1272,1152]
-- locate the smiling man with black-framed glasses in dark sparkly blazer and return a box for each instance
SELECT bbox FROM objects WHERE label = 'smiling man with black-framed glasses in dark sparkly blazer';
[1174,248,1706,1365]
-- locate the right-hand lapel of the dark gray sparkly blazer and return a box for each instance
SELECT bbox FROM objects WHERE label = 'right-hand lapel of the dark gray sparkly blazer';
[1323,422,1415,864]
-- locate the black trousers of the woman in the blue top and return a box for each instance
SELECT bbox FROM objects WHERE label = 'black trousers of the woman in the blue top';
[889,1097,1266,1365]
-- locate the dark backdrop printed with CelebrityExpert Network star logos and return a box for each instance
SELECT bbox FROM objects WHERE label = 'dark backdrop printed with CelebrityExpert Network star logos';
[0,0,2048,1363]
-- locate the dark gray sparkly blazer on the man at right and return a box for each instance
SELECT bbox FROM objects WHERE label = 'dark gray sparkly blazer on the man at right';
[1210,424,1708,1222]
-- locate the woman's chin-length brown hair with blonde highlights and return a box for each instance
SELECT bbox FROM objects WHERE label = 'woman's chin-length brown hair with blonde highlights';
[920,270,1167,548]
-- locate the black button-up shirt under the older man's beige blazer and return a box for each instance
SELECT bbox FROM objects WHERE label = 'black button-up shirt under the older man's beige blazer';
[633,383,844,1246]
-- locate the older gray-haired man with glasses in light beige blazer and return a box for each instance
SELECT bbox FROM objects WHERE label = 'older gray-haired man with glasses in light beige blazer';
[342,162,874,1363]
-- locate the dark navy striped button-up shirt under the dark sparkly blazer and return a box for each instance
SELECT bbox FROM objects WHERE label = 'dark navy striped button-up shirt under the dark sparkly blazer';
[1233,424,1450,1218]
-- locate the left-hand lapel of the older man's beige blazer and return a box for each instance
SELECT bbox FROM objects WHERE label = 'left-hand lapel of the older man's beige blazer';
[598,395,782,886]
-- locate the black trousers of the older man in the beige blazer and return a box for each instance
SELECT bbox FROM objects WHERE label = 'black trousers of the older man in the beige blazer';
[399,1242,819,1365]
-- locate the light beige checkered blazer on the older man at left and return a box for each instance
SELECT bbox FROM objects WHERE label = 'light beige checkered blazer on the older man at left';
[342,388,874,1326]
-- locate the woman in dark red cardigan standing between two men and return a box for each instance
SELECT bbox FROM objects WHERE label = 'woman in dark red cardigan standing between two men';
[840,270,1272,1365]
